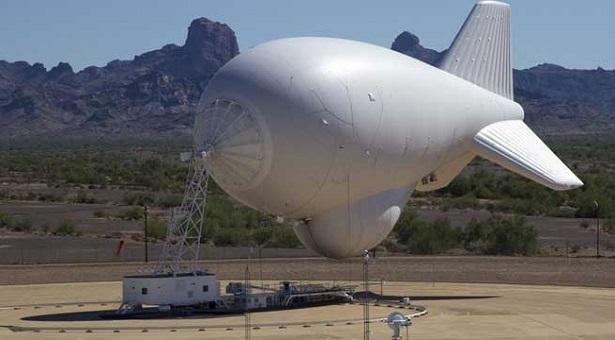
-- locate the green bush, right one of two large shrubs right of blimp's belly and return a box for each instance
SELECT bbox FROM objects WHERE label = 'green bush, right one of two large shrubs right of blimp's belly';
[464,216,538,255]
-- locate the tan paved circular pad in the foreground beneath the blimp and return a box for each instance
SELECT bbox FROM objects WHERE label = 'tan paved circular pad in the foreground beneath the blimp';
[0,282,615,340]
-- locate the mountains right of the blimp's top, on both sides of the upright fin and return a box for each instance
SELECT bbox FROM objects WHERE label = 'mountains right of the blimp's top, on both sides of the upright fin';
[391,32,615,134]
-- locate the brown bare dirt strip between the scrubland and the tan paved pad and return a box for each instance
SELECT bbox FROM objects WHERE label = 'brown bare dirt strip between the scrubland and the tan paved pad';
[0,256,615,288]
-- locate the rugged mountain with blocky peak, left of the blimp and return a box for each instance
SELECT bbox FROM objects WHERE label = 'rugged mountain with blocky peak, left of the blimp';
[0,18,239,137]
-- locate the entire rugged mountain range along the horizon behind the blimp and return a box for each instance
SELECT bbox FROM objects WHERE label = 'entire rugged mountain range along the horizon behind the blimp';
[0,18,615,138]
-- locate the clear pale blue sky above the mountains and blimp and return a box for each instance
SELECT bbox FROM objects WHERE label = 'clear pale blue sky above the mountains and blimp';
[0,0,615,70]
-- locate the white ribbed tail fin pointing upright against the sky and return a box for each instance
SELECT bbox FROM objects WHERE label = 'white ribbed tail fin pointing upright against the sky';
[440,1,513,100]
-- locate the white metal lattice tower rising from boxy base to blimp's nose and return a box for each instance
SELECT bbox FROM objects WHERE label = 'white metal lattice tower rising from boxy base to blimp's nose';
[154,152,209,274]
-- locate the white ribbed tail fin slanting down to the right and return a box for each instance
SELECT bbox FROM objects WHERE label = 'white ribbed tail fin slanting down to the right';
[474,120,583,190]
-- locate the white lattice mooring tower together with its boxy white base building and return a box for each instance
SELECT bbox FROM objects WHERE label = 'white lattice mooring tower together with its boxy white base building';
[118,152,220,314]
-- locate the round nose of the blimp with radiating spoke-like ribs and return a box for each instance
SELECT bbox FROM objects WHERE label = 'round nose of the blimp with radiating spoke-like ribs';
[194,99,271,191]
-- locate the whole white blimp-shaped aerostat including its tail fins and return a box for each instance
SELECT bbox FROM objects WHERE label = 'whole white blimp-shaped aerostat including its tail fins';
[195,1,582,258]
